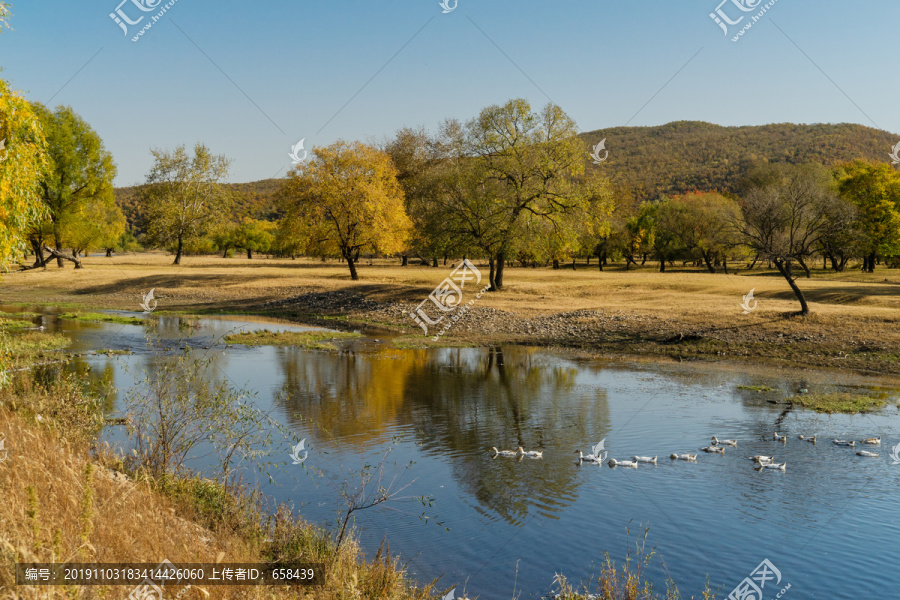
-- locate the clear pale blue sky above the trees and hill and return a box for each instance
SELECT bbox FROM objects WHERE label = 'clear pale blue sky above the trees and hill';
[0,0,900,185]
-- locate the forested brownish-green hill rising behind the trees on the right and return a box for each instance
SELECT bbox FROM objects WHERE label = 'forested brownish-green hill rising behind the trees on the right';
[582,121,900,199]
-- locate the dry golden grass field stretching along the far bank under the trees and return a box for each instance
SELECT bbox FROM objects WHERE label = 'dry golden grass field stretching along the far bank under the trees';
[0,253,900,373]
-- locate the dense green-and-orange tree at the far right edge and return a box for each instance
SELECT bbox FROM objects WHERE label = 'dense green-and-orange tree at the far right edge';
[836,161,900,273]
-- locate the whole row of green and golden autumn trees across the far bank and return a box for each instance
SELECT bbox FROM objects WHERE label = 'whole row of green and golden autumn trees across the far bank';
[0,54,900,313]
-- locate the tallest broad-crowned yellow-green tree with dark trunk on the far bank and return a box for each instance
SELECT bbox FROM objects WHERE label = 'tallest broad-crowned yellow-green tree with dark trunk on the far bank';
[436,99,611,291]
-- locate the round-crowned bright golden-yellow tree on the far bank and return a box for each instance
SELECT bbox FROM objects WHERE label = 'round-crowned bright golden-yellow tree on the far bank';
[278,141,411,281]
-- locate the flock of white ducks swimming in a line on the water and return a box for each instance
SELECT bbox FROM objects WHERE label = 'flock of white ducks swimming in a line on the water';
[492,431,881,471]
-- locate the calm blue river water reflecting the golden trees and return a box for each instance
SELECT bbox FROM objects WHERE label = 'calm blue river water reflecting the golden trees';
[8,308,900,600]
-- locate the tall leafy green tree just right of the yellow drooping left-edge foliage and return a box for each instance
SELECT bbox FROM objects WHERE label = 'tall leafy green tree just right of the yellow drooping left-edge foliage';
[32,104,118,268]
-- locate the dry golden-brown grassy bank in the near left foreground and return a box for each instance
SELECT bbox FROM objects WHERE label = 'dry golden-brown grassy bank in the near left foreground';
[0,377,440,600]
